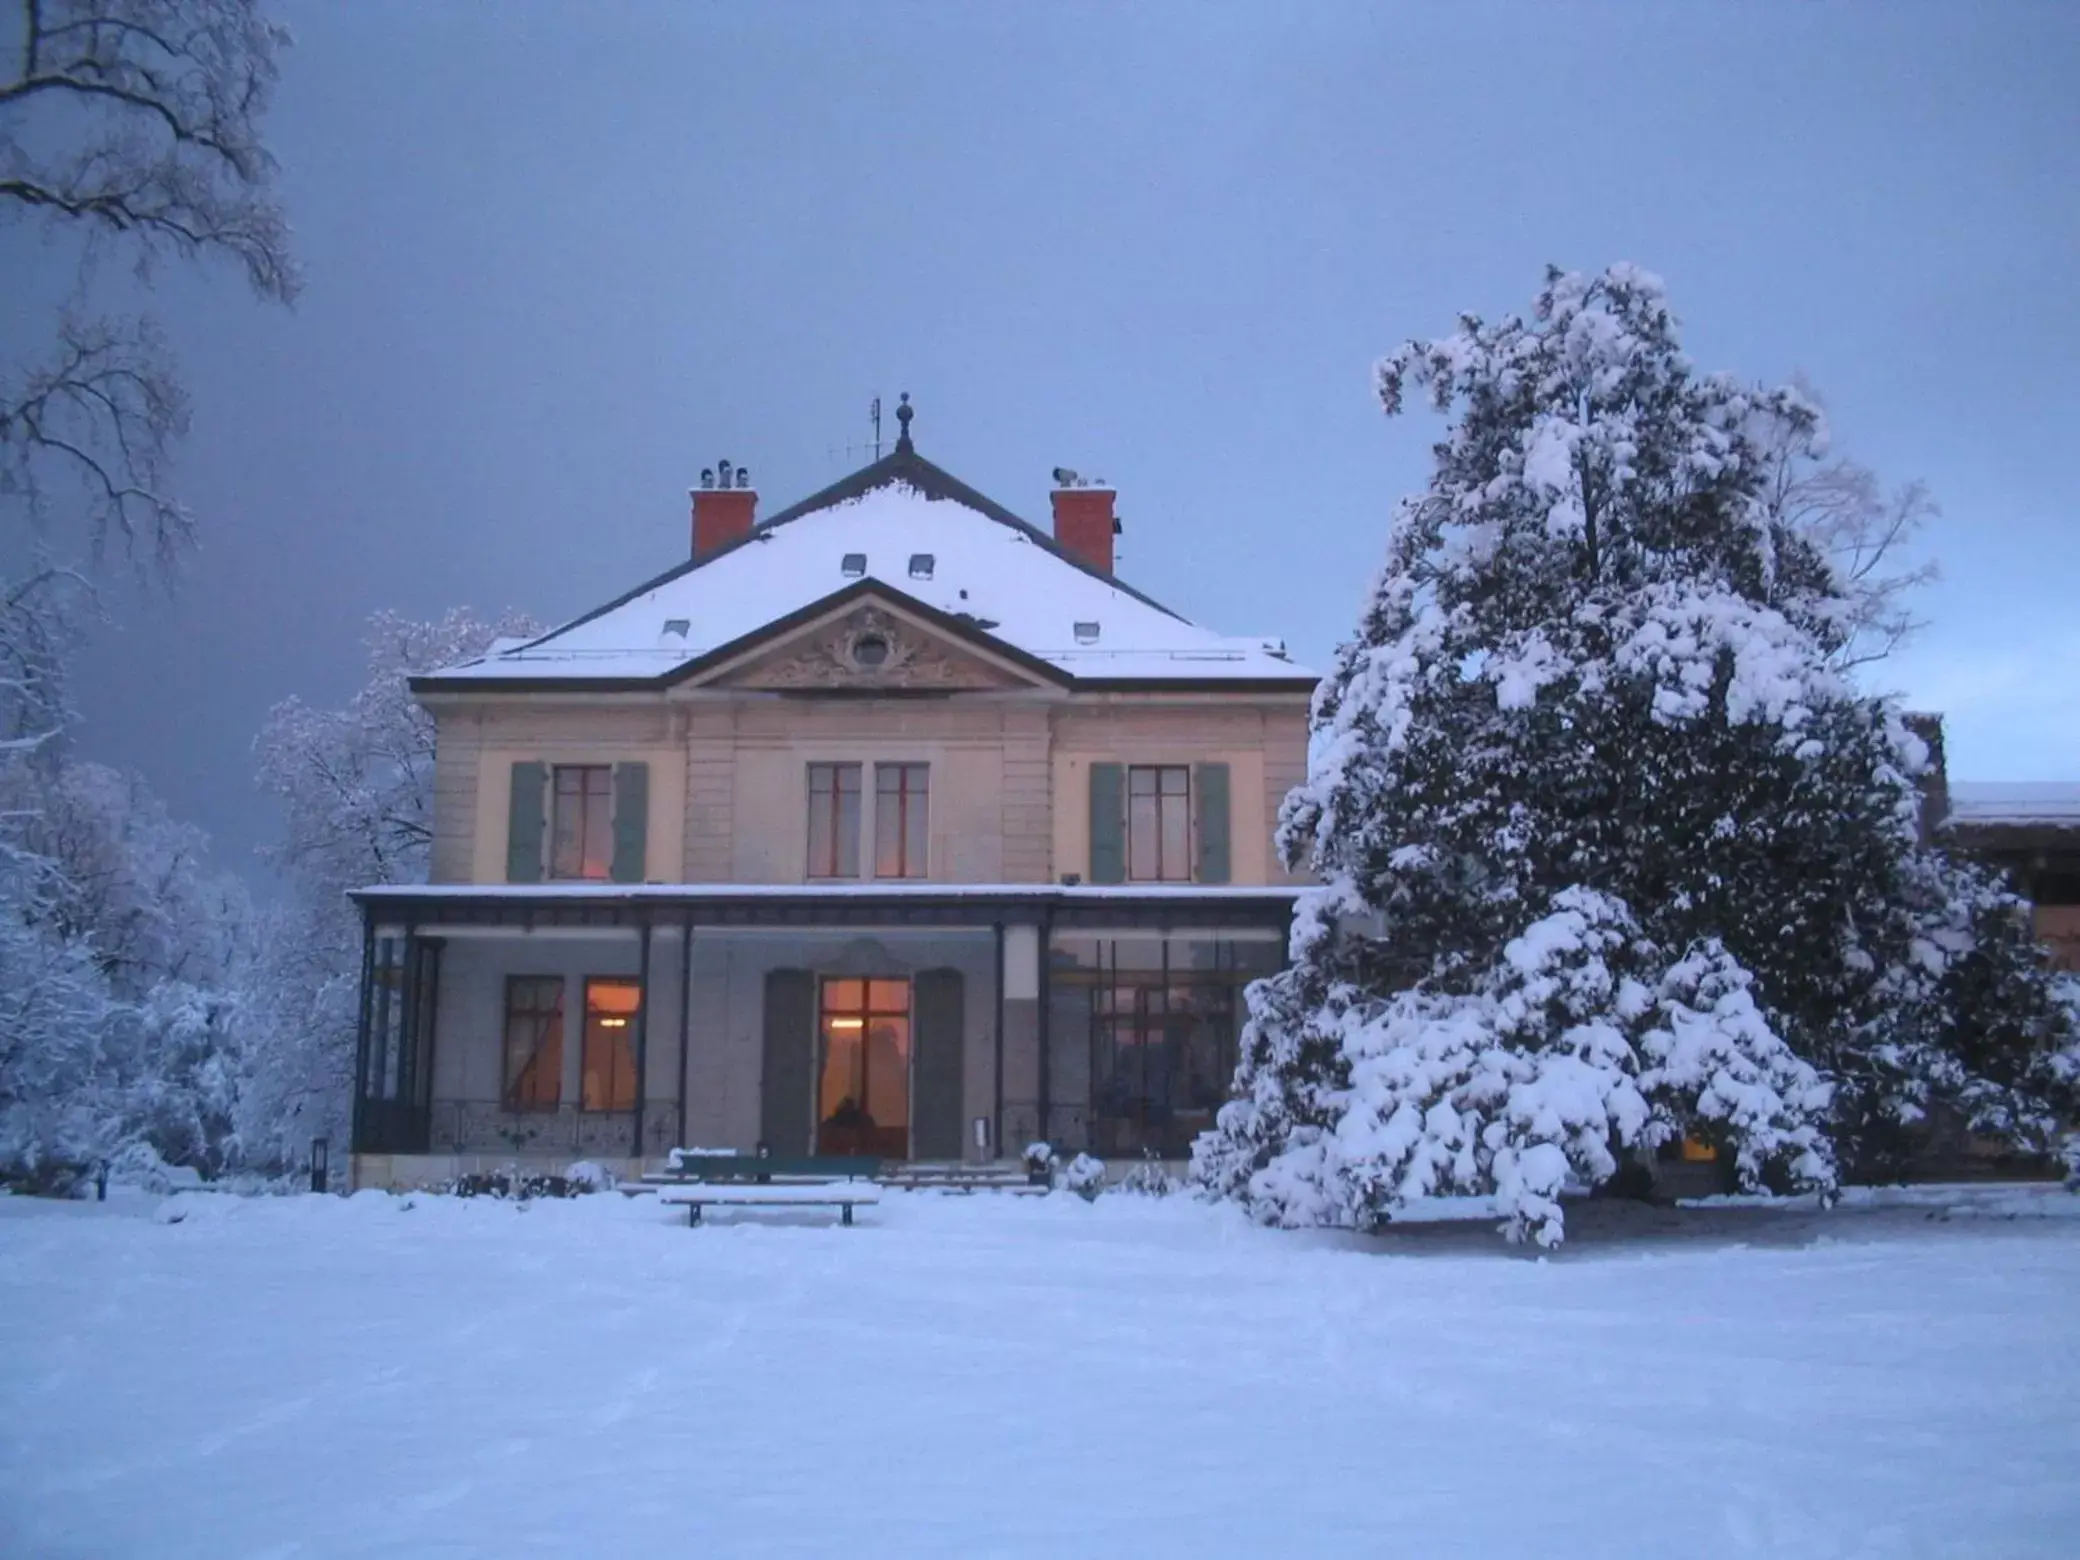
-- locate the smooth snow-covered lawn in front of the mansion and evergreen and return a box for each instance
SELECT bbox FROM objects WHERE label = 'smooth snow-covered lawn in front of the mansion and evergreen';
[0,1190,2080,1560]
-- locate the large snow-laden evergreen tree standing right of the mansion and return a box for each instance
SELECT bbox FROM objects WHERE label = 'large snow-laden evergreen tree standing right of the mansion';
[1196,266,2070,1242]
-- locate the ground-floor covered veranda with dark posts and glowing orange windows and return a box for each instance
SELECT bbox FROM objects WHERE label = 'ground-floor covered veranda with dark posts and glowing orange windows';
[354,884,1296,1184]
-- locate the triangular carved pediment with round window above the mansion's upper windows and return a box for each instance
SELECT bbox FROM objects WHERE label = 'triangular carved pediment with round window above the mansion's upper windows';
[697,595,1042,695]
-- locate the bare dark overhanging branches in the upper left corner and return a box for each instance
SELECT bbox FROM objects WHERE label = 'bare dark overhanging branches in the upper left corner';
[0,0,300,564]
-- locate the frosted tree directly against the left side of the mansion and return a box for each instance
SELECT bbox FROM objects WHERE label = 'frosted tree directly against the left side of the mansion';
[239,607,541,1163]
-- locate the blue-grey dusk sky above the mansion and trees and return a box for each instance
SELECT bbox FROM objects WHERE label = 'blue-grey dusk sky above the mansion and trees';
[16,0,2080,881]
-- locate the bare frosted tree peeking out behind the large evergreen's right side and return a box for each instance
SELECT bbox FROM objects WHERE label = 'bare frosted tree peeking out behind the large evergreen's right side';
[1766,379,1941,668]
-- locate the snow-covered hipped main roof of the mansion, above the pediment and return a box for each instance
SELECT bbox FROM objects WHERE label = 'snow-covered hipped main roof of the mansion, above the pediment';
[428,449,1315,686]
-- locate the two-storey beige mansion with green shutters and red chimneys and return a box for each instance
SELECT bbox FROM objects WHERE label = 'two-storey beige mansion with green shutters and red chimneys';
[354,406,1315,1186]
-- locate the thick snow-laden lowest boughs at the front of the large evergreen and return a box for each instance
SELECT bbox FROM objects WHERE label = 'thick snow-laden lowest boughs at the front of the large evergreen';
[1200,888,1835,1246]
